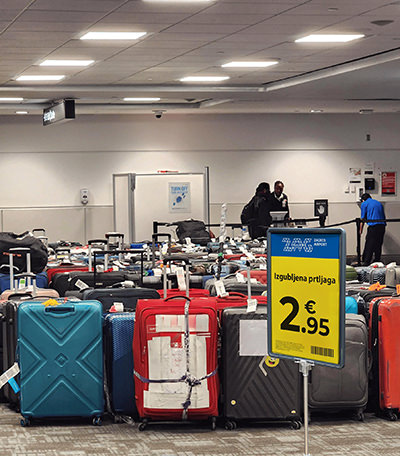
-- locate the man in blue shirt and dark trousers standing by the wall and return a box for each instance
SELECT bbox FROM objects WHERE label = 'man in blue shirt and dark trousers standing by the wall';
[360,193,386,265]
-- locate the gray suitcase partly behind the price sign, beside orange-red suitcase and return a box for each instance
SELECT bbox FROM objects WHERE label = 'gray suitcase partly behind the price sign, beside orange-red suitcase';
[308,314,369,421]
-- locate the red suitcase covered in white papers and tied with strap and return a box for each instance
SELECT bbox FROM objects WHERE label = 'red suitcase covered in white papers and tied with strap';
[133,297,219,431]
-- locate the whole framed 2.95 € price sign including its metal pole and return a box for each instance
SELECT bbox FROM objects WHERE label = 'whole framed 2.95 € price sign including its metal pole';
[267,228,346,456]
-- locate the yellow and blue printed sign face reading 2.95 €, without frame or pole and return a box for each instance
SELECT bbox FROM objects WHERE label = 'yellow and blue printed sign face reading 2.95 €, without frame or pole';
[268,228,344,365]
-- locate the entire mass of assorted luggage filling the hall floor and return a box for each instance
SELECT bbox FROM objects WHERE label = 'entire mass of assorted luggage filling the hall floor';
[0,228,400,430]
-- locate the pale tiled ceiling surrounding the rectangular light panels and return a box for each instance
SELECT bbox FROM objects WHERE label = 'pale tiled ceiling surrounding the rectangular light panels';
[0,0,400,114]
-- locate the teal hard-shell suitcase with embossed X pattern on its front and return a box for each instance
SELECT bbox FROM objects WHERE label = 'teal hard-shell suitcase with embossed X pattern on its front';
[17,301,104,425]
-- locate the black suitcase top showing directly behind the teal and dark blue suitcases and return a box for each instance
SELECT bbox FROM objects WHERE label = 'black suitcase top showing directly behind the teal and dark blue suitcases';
[82,288,160,312]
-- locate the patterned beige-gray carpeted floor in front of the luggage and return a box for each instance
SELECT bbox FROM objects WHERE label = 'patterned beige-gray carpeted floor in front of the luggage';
[0,404,400,456]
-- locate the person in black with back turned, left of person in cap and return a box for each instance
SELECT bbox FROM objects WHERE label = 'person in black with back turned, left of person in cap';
[240,182,272,239]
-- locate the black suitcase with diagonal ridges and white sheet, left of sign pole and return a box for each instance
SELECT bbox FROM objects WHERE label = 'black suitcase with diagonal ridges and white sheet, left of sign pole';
[222,306,302,429]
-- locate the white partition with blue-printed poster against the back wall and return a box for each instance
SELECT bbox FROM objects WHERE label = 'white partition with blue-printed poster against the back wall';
[113,168,209,242]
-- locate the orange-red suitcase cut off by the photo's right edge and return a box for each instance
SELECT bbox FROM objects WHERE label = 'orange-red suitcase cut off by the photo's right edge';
[369,297,400,421]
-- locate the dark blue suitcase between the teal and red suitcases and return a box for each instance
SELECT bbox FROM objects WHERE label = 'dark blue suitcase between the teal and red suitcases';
[104,312,137,418]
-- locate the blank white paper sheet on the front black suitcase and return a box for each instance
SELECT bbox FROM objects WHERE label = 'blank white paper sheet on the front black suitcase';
[239,320,268,356]
